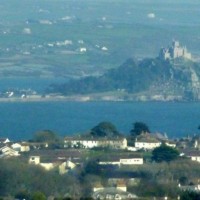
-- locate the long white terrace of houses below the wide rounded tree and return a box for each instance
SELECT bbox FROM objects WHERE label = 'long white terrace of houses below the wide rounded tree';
[64,137,127,149]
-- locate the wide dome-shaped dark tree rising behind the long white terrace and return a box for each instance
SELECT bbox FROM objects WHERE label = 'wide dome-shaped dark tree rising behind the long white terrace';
[91,122,120,137]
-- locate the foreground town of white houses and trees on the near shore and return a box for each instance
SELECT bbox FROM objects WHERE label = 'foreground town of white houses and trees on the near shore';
[0,122,200,199]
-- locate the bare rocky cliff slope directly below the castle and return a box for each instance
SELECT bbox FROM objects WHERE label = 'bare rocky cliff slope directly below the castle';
[133,59,200,100]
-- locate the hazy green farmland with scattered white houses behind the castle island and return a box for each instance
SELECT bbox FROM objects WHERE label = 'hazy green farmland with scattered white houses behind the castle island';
[0,0,200,77]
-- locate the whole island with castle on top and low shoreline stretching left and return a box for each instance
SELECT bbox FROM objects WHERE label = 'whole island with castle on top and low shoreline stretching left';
[0,41,200,102]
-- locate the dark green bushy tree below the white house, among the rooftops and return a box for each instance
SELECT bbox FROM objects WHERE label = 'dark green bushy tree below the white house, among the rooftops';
[152,144,179,162]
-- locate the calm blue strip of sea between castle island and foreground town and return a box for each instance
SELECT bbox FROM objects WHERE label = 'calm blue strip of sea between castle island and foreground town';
[0,102,200,140]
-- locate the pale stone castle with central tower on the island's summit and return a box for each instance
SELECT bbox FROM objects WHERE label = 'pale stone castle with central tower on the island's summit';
[159,41,192,60]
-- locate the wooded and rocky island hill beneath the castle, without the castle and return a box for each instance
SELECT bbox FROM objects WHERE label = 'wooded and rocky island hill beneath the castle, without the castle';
[47,58,200,100]
